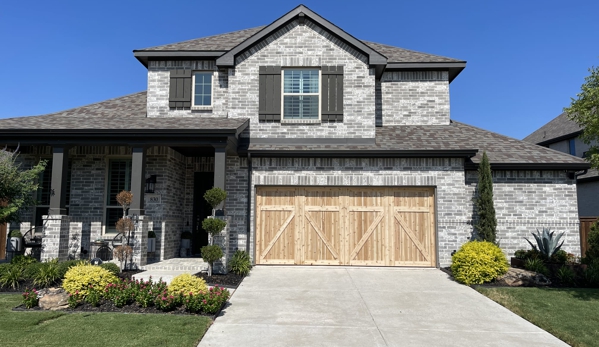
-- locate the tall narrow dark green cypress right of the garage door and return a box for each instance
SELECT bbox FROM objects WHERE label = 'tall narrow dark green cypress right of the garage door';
[475,152,497,243]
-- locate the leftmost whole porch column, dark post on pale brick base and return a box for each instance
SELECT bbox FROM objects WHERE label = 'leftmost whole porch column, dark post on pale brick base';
[41,146,70,261]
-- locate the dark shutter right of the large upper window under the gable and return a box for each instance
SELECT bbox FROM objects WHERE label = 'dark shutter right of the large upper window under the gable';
[320,66,343,122]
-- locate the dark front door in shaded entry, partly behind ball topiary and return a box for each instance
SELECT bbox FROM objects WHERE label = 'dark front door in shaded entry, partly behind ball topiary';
[191,172,214,257]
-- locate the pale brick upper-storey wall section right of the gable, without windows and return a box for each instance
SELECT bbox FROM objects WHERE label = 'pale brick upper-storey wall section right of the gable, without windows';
[380,71,449,126]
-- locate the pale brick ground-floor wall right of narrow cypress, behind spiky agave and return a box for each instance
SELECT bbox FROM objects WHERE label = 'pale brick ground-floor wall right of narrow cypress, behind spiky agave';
[466,171,580,256]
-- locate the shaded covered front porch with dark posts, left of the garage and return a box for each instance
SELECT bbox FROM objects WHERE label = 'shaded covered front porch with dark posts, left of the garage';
[1,119,247,271]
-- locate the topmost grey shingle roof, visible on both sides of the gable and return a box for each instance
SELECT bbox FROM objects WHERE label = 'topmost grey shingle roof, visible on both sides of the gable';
[139,26,462,63]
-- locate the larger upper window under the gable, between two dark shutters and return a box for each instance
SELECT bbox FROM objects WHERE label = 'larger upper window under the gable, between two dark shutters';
[282,69,320,119]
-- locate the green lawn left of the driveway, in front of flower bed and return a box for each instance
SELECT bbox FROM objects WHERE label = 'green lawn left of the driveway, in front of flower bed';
[0,294,212,347]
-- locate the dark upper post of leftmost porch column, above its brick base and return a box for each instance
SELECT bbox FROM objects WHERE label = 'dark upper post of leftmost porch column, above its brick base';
[48,146,69,215]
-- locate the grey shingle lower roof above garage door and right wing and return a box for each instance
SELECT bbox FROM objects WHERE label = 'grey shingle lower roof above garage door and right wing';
[247,121,588,169]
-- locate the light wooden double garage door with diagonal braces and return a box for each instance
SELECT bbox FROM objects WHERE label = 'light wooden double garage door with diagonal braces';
[256,187,436,266]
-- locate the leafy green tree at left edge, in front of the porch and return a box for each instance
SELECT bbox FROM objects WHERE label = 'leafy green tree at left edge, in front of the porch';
[0,147,46,224]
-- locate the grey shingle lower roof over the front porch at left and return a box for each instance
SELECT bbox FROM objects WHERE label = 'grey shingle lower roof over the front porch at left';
[0,92,247,132]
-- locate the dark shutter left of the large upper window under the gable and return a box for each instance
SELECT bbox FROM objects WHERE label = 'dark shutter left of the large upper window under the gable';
[258,66,281,121]
